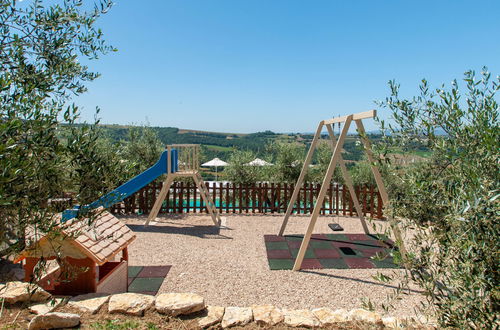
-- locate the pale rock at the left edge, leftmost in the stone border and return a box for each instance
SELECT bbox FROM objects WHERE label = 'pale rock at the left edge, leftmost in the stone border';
[0,281,51,304]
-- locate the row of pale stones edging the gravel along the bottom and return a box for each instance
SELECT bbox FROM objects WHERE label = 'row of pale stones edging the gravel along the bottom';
[0,282,435,329]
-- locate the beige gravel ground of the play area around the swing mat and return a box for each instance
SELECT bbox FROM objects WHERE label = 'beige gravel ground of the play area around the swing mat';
[122,215,422,316]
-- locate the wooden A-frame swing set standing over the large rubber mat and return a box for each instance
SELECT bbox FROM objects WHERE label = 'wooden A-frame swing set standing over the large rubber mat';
[279,110,405,270]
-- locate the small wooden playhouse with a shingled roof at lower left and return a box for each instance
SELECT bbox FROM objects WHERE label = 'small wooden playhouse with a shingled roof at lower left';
[16,208,135,295]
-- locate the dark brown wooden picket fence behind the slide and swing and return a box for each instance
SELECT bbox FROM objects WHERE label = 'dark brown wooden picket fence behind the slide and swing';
[111,181,383,219]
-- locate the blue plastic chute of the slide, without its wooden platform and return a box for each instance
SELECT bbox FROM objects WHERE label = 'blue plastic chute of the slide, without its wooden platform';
[61,149,179,222]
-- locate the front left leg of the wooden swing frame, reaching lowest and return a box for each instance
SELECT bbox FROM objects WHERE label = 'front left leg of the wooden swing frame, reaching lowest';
[293,115,353,270]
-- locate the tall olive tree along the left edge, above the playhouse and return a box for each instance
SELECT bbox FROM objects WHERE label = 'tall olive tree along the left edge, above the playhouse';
[0,0,113,256]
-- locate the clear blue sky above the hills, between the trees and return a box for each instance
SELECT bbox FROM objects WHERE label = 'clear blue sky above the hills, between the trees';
[75,0,500,133]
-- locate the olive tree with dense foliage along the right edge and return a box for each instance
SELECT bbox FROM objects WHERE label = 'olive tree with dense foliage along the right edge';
[381,69,500,328]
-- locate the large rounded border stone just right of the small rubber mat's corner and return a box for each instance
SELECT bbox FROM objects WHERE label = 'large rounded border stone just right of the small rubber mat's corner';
[155,293,205,316]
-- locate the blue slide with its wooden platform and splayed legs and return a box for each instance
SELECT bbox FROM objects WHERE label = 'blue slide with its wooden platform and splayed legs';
[61,144,221,226]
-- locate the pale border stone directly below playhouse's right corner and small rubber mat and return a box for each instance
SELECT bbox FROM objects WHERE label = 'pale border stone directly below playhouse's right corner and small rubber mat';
[108,292,155,316]
